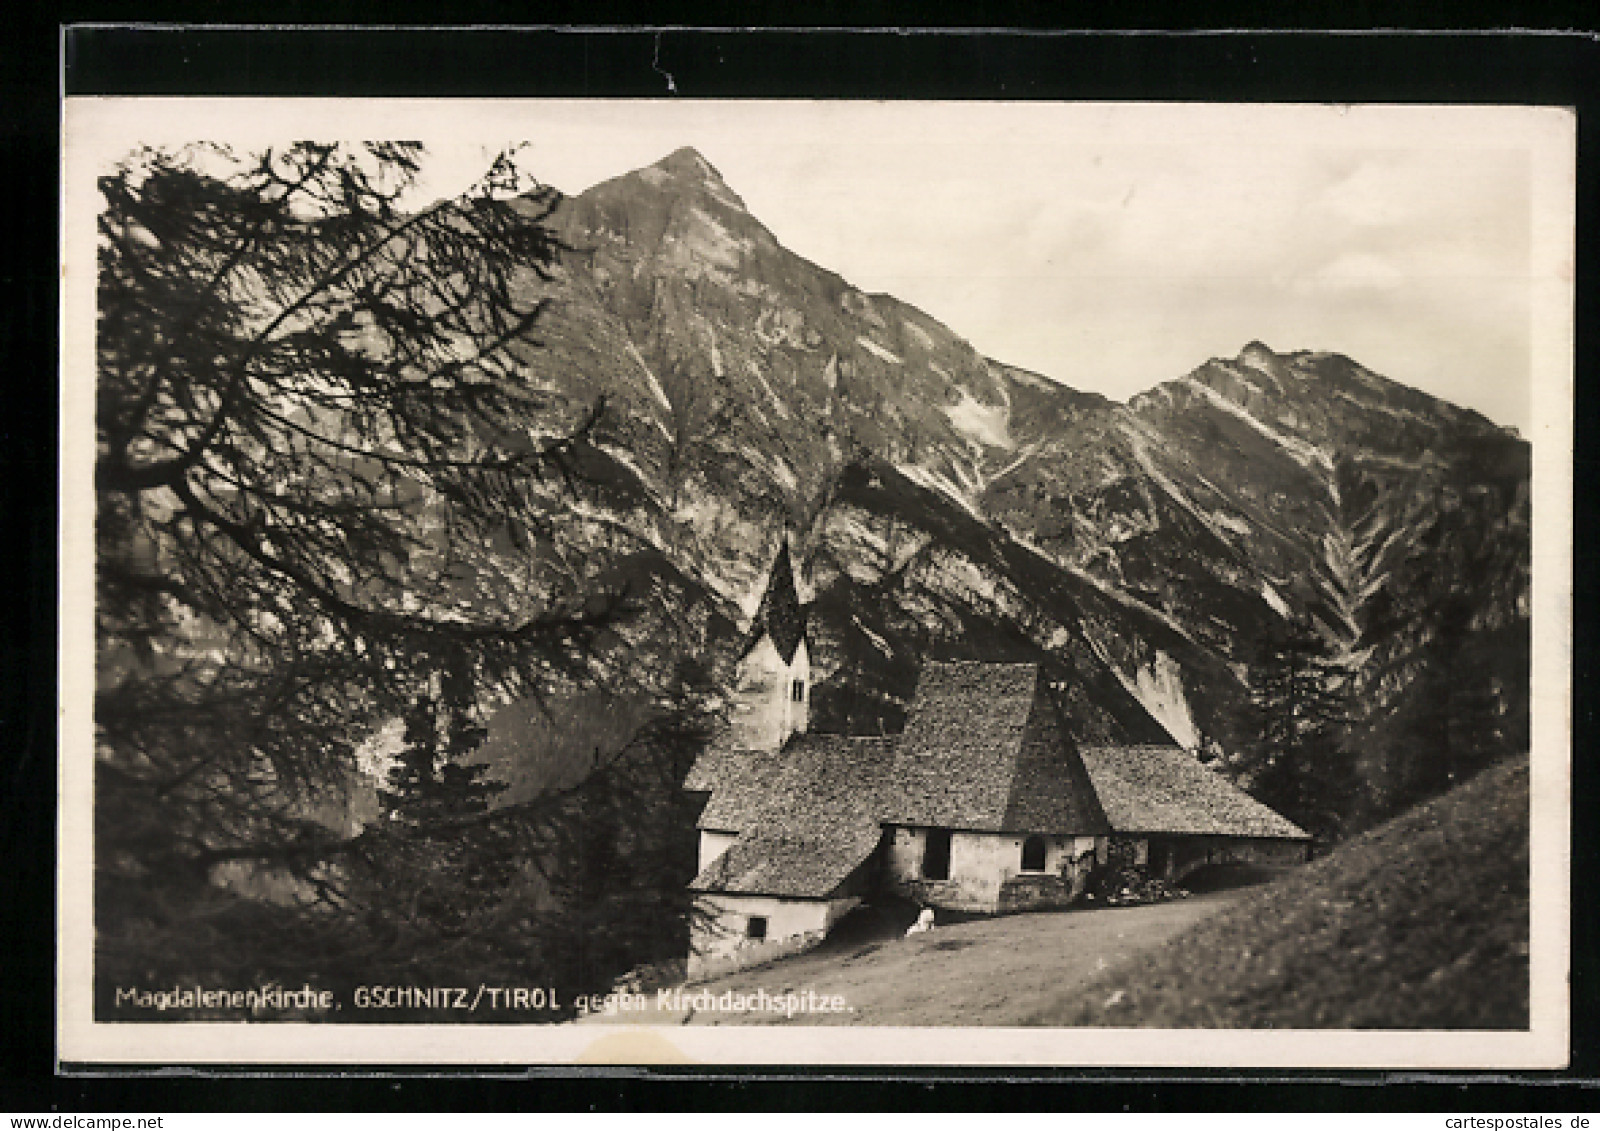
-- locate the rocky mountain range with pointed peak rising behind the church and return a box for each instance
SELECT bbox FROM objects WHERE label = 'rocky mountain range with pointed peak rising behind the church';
[492,149,1530,825]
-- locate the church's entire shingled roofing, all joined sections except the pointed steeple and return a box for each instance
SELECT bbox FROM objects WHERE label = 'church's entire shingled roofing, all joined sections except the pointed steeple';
[683,659,1307,899]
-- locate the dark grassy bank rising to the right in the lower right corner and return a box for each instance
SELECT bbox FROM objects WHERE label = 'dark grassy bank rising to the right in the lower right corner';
[1027,758,1528,1029]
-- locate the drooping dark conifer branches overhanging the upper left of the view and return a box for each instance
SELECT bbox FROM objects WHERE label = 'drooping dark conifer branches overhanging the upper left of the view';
[96,142,653,883]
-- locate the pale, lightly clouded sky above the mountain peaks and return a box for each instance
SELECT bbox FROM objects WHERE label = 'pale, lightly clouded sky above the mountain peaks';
[69,99,1571,434]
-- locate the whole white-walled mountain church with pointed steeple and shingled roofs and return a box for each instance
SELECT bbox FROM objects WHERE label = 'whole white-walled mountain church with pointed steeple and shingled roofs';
[683,544,1310,977]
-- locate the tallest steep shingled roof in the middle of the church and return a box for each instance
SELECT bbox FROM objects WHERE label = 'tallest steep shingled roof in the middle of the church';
[883,661,1109,835]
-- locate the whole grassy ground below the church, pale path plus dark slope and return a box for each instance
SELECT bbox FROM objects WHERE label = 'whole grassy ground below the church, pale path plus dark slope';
[590,758,1528,1029]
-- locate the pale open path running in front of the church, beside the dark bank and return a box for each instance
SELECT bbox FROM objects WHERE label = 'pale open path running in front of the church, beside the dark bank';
[586,889,1243,1025]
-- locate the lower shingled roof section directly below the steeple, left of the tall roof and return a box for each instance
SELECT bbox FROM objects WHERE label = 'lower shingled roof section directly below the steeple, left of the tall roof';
[690,734,894,899]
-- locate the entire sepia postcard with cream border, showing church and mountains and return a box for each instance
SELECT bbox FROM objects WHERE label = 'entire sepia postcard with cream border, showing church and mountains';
[59,98,1574,1069]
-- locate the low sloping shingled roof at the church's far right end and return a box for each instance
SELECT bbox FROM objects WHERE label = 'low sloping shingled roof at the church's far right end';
[1078,745,1310,840]
